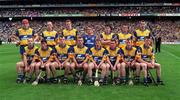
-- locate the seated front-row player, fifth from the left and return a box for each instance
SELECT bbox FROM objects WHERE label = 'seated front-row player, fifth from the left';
[88,39,107,83]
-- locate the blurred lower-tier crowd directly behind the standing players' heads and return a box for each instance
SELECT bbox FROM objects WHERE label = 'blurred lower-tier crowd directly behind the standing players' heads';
[0,19,180,42]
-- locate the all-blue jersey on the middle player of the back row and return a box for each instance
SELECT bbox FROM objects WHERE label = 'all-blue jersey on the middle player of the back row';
[83,34,96,50]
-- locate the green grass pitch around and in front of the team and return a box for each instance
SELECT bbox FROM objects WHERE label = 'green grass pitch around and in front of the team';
[0,45,180,100]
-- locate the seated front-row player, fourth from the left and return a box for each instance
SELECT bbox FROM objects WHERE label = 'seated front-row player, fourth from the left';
[70,36,91,85]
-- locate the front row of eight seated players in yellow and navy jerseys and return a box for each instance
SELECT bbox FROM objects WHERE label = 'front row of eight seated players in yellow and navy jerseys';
[17,36,162,86]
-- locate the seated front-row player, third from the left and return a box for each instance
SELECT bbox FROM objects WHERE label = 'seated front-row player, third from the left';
[51,36,72,83]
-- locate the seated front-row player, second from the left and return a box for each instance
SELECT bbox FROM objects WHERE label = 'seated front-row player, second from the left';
[32,39,54,83]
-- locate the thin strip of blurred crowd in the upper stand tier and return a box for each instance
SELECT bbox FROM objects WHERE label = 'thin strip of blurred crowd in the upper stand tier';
[0,7,180,17]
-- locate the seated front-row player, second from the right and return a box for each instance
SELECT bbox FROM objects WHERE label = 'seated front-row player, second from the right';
[121,39,140,85]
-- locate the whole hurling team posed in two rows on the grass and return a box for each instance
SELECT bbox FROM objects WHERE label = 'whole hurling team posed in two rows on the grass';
[15,19,163,86]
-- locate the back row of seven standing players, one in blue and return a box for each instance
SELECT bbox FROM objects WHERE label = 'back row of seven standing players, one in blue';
[14,19,151,54]
